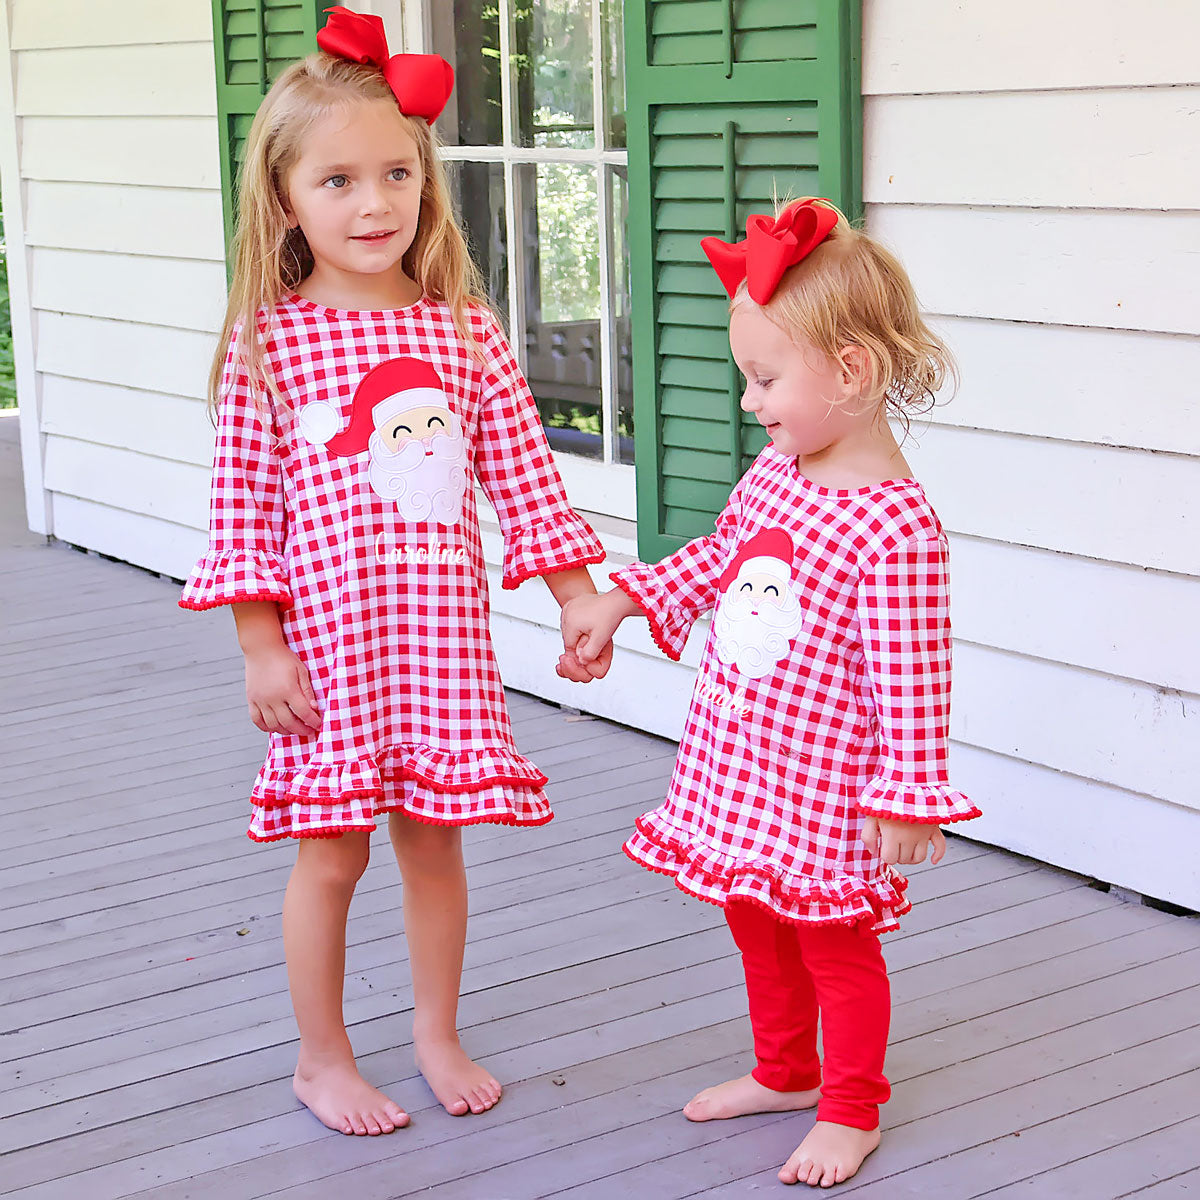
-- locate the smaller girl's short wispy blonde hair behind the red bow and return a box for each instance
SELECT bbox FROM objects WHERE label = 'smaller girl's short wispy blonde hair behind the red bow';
[731,200,958,430]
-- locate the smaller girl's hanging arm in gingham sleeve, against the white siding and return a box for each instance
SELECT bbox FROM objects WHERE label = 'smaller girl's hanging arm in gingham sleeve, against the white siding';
[858,536,979,863]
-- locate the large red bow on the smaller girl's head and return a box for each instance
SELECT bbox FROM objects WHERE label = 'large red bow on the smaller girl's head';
[700,197,838,304]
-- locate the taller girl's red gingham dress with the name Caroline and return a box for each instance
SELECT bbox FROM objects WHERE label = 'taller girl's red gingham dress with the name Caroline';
[180,296,604,841]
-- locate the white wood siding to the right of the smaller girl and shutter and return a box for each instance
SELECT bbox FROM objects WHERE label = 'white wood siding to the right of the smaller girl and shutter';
[863,0,1200,906]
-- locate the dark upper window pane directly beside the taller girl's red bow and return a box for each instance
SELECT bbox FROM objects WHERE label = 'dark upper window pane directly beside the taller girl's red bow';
[430,0,503,146]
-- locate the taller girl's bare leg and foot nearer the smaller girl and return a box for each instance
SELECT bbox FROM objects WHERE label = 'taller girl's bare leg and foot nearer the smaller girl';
[389,812,500,1117]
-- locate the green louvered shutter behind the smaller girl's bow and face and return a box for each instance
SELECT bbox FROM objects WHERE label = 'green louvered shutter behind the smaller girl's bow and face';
[625,0,862,560]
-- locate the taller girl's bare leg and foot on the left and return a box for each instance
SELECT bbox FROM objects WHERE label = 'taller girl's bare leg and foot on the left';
[283,833,408,1134]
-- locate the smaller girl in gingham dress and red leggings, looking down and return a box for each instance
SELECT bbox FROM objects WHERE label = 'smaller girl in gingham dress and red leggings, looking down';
[562,199,979,1187]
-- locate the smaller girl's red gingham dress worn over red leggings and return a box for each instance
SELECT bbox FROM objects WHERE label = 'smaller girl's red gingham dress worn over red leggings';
[612,446,979,932]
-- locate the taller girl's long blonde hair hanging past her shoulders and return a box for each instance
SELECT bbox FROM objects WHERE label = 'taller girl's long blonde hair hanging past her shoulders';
[208,53,487,414]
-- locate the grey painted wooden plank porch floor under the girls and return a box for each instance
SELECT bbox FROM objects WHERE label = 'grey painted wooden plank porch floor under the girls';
[7,416,1200,1200]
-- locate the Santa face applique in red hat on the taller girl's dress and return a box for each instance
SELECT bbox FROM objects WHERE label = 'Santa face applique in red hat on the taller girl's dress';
[299,359,467,526]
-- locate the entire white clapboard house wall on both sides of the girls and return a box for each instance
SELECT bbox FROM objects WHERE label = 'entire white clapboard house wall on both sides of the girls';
[9,0,1200,907]
